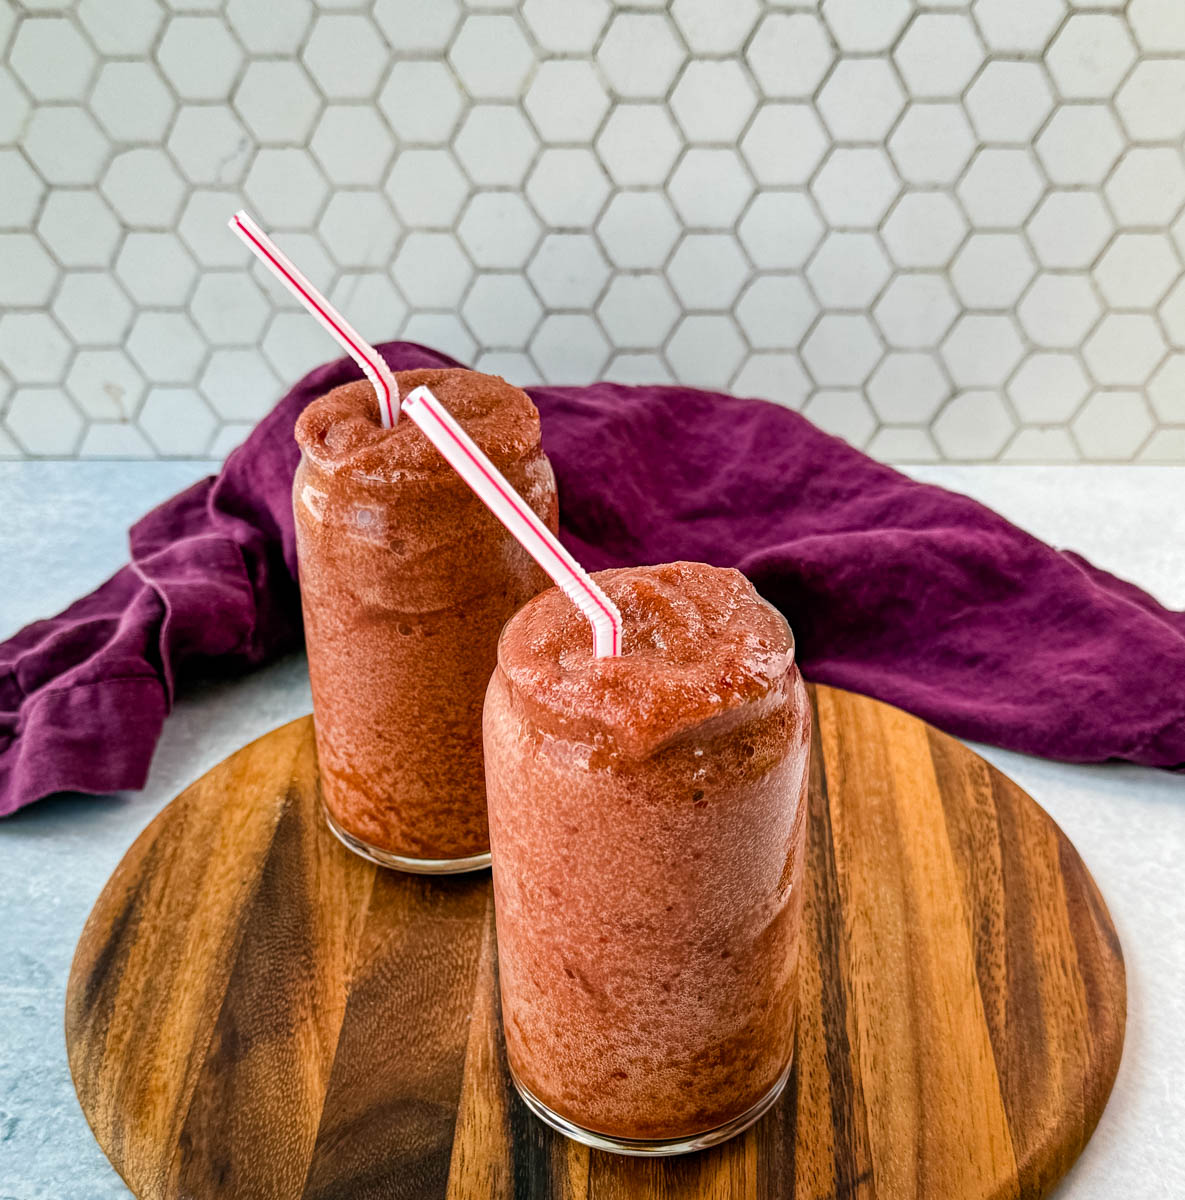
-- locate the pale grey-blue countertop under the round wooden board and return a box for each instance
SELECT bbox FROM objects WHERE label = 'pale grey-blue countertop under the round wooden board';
[0,462,1185,1200]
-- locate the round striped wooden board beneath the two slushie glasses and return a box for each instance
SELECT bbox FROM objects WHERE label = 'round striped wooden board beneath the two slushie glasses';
[66,686,1125,1200]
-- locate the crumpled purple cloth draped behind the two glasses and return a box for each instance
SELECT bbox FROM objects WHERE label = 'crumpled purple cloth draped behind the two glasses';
[0,342,1185,815]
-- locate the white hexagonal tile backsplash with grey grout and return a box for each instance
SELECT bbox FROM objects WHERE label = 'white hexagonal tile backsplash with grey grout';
[0,0,1185,463]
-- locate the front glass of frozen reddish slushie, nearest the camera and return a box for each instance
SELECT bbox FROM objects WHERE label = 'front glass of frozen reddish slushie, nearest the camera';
[485,563,811,1154]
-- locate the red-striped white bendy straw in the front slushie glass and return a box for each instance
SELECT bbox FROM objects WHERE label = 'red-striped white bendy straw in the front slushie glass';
[402,388,621,659]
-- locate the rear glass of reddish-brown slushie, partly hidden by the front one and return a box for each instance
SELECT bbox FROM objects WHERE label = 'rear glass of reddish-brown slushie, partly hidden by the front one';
[293,370,558,871]
